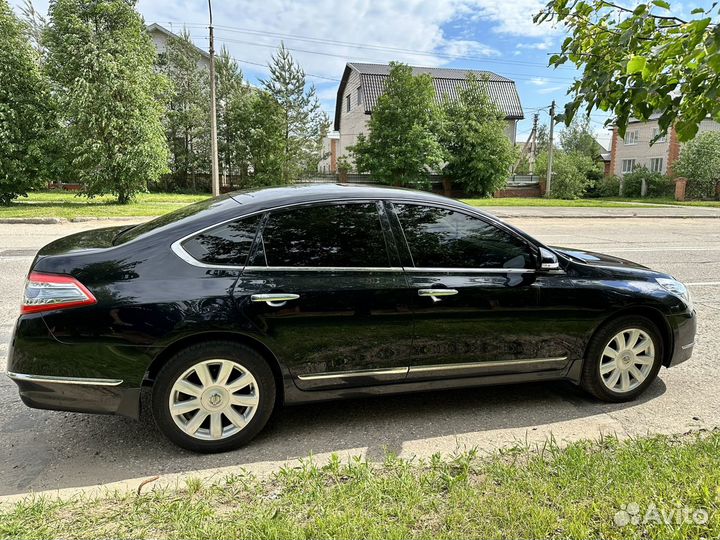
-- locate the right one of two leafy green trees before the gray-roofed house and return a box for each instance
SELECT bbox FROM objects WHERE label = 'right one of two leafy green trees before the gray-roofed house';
[441,74,516,197]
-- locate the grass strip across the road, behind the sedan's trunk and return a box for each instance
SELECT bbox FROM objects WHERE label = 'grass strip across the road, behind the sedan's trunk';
[0,191,210,219]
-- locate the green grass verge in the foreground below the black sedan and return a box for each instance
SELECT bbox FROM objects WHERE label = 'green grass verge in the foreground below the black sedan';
[0,433,720,540]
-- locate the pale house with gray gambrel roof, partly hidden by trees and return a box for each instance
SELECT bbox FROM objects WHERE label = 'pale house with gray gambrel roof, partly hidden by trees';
[320,62,523,172]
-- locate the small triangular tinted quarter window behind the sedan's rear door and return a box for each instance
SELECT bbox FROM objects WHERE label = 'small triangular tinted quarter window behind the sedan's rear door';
[182,215,261,266]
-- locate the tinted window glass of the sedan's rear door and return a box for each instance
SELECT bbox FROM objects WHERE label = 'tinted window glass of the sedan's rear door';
[254,203,389,267]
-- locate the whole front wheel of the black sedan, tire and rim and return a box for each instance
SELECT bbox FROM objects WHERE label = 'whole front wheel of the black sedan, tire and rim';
[580,315,664,403]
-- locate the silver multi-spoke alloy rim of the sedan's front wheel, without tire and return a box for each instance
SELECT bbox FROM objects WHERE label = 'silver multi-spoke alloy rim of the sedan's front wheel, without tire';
[600,328,655,393]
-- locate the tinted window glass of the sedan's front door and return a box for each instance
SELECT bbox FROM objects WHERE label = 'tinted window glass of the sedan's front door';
[394,204,532,268]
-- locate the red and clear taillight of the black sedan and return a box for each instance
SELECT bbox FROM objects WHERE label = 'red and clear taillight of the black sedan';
[20,272,97,313]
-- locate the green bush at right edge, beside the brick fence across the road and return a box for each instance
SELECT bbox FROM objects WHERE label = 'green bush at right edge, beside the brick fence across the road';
[673,131,720,197]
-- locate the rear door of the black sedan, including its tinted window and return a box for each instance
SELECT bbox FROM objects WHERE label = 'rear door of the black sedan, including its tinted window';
[234,201,413,390]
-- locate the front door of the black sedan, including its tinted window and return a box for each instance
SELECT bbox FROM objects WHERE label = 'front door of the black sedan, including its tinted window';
[390,202,567,380]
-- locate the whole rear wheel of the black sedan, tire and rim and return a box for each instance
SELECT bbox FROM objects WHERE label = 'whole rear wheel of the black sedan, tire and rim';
[152,341,277,453]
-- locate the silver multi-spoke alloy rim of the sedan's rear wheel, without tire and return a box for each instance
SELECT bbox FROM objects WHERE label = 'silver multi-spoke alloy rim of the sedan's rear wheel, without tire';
[168,359,260,440]
